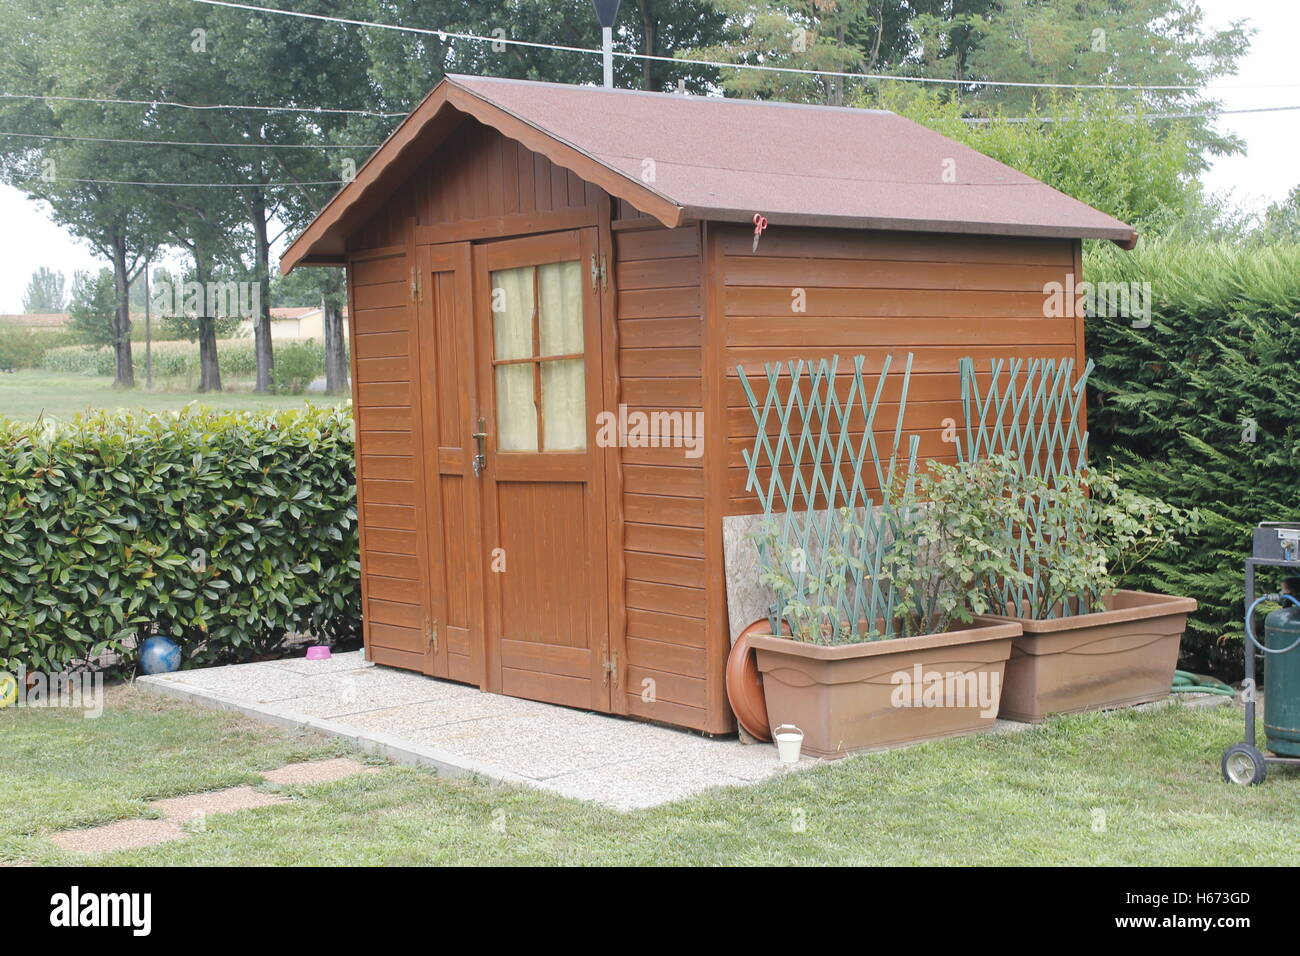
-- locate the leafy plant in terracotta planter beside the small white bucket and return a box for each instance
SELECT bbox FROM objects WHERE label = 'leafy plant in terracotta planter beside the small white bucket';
[750,460,1022,757]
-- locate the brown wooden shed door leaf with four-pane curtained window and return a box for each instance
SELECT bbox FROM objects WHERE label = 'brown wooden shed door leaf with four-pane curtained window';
[475,229,610,710]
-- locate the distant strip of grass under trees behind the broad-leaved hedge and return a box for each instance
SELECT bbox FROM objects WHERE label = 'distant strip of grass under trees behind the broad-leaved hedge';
[0,368,339,420]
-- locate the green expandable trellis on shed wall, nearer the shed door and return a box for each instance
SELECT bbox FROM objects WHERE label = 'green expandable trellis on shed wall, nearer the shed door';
[736,354,919,643]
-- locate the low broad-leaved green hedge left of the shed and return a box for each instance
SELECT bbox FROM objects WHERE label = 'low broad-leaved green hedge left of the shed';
[0,406,360,670]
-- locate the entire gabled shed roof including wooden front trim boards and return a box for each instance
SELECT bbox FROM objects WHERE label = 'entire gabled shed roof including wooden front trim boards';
[281,74,1136,272]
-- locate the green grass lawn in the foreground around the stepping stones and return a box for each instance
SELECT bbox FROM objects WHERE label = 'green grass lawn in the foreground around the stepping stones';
[0,687,1300,865]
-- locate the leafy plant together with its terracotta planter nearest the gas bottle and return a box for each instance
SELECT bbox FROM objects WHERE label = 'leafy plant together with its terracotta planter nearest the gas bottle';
[984,470,1197,722]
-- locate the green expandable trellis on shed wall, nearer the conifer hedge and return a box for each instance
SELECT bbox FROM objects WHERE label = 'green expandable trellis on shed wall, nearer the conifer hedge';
[957,358,1093,617]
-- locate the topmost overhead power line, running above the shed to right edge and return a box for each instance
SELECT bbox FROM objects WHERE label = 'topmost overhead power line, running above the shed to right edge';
[191,0,1300,92]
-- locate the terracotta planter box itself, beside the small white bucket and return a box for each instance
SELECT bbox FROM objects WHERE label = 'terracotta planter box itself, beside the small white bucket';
[750,618,1021,757]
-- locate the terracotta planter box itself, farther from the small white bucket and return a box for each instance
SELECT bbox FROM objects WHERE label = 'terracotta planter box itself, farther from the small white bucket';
[998,591,1196,723]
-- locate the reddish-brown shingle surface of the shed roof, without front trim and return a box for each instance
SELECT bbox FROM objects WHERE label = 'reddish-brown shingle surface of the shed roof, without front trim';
[449,75,1134,241]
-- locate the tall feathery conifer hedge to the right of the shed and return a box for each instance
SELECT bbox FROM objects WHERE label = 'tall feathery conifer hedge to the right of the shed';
[1087,241,1300,678]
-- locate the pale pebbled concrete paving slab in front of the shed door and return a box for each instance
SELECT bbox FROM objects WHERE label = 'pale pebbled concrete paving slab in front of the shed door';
[137,652,815,810]
